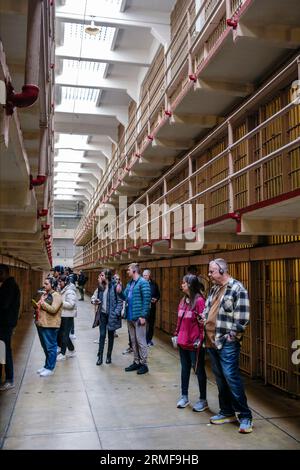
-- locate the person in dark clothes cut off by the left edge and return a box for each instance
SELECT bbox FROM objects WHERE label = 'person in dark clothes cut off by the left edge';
[0,264,20,391]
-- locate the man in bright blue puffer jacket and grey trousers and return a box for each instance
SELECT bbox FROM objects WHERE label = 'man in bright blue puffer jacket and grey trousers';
[117,263,151,375]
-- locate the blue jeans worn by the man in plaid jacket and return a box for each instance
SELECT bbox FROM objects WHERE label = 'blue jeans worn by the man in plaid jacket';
[207,340,252,419]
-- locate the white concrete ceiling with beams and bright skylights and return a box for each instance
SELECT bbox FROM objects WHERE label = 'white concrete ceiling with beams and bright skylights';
[54,0,175,211]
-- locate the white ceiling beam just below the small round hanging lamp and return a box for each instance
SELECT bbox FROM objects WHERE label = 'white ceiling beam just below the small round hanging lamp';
[55,46,151,67]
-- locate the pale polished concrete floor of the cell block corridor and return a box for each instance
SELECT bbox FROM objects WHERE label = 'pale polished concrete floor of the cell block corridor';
[0,301,300,450]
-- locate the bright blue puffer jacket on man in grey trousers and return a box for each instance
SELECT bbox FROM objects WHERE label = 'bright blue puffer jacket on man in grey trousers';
[120,277,151,320]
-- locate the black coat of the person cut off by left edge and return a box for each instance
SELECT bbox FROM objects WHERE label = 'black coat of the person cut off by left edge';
[0,277,21,328]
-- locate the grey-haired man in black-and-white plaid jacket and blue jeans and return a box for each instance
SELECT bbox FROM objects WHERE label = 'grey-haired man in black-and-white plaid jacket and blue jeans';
[204,258,252,434]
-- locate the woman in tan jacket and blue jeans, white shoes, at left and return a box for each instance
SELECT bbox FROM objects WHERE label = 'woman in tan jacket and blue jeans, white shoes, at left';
[35,279,62,377]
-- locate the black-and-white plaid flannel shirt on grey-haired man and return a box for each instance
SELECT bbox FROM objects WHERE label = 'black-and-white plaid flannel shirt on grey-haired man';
[203,277,250,349]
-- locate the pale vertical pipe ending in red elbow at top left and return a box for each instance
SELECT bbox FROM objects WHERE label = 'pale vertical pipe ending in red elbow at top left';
[6,0,43,115]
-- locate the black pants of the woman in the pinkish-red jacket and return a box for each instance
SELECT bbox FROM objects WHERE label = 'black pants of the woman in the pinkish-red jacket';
[179,347,207,400]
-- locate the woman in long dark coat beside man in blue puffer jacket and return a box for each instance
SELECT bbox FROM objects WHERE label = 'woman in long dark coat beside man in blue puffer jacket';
[91,269,123,366]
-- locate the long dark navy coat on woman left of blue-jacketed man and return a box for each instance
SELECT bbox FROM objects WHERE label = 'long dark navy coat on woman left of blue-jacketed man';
[92,282,123,331]
